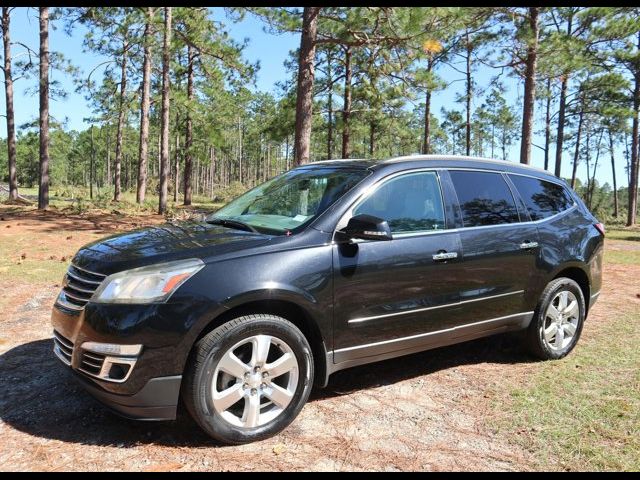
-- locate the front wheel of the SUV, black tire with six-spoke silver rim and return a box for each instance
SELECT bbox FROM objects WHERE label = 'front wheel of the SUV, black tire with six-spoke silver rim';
[182,315,313,445]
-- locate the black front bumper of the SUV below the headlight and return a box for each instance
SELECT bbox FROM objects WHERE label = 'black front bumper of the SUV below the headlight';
[51,305,192,420]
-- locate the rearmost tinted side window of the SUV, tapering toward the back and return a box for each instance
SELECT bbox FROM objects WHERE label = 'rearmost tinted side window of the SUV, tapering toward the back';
[509,175,573,221]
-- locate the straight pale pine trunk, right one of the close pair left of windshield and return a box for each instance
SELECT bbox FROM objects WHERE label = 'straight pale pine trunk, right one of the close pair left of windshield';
[158,7,172,215]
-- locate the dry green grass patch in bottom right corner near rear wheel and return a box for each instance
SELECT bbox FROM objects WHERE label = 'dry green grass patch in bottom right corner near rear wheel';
[502,313,640,471]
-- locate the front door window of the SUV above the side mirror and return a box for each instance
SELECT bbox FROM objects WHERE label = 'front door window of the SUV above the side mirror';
[353,172,445,234]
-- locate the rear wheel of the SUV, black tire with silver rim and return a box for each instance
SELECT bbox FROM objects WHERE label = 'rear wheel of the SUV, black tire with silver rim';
[526,277,586,360]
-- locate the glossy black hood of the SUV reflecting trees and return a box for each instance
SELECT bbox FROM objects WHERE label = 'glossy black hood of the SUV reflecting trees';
[72,222,273,275]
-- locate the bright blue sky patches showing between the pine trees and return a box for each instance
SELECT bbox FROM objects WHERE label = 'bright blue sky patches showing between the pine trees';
[0,8,626,185]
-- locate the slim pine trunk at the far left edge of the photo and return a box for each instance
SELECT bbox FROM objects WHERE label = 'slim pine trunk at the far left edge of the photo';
[2,7,18,200]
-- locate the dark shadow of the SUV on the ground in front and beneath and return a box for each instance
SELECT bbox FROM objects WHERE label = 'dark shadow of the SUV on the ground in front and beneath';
[0,335,532,448]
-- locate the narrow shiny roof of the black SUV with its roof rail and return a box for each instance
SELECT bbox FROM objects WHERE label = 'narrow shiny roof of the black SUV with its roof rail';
[308,155,557,180]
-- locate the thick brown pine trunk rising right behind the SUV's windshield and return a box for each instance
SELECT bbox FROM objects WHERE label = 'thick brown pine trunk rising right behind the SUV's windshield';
[293,7,322,165]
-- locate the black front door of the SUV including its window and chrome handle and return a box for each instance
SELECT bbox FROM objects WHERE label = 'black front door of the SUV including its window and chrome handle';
[333,171,464,363]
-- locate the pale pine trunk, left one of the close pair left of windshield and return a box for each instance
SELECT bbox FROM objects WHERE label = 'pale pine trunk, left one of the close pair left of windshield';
[136,7,153,203]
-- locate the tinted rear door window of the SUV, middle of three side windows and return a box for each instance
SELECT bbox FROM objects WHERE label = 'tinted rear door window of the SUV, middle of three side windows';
[449,170,519,227]
